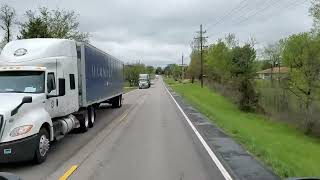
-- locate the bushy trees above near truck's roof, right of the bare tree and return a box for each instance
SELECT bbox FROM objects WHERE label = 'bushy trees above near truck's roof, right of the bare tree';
[18,8,89,42]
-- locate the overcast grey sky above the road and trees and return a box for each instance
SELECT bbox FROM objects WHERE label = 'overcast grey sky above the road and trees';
[0,0,312,66]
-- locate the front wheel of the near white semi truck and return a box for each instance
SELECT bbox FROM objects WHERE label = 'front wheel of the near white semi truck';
[34,128,50,164]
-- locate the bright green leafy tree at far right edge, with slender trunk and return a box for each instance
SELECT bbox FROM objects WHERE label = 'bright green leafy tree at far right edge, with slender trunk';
[283,33,320,134]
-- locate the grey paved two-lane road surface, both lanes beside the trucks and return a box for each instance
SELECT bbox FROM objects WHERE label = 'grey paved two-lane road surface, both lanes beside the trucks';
[0,79,224,180]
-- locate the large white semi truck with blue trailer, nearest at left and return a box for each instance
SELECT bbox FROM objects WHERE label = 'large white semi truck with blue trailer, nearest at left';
[0,39,123,163]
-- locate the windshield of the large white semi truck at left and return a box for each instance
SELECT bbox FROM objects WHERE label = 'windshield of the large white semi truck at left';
[0,71,45,93]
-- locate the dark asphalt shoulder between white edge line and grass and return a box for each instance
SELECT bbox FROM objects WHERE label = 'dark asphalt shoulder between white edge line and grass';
[167,86,280,180]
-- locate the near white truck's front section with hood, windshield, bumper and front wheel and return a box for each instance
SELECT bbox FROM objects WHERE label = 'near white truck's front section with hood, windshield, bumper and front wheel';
[0,66,64,162]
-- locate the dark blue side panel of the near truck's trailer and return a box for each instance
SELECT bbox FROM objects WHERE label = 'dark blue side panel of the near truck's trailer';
[81,45,123,106]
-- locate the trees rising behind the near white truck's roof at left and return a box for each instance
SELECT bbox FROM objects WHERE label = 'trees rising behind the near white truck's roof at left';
[0,4,89,48]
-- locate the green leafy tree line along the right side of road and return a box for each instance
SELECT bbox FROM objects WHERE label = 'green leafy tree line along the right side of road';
[170,0,320,134]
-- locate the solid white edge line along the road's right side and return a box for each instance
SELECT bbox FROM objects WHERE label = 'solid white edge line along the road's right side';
[164,86,232,180]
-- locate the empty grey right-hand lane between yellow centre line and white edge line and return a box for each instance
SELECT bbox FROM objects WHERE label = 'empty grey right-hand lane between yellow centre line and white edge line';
[69,79,224,180]
